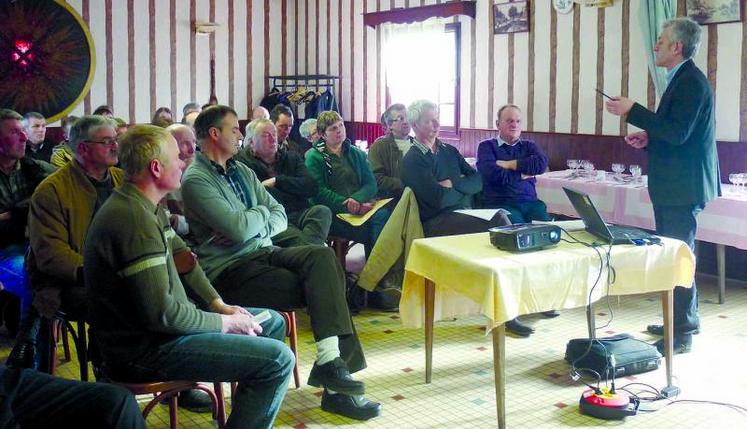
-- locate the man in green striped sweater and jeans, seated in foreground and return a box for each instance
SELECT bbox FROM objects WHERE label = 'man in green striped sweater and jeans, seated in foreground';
[83,125,294,428]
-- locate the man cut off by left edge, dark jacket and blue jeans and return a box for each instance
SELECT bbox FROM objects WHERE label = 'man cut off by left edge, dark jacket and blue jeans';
[0,109,54,368]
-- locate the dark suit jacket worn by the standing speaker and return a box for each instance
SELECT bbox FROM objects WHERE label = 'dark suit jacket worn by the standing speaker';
[627,59,721,206]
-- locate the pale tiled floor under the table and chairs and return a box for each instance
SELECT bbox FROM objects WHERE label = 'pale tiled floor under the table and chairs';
[0,251,747,429]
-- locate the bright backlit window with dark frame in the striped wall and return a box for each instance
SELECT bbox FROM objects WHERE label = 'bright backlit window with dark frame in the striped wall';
[383,19,461,133]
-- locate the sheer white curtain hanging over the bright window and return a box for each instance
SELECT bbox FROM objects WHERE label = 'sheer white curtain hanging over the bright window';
[382,18,444,106]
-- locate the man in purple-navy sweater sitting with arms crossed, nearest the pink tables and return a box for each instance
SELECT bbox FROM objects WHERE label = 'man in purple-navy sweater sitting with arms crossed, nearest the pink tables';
[477,104,559,337]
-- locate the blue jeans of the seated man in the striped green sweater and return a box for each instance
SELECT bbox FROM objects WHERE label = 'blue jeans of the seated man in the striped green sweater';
[111,308,295,428]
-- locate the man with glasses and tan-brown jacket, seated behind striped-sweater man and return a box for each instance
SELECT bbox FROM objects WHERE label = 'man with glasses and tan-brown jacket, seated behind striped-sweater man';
[27,116,124,318]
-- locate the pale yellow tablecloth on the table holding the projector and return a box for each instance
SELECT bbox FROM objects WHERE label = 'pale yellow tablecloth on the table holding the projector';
[399,232,695,328]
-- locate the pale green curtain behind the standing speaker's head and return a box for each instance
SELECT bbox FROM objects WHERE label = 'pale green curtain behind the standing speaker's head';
[638,0,677,98]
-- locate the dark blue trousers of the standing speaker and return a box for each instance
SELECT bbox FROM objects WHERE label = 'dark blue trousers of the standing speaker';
[654,204,705,336]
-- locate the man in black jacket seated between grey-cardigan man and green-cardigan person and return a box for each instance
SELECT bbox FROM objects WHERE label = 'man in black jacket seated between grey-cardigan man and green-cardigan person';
[235,119,332,247]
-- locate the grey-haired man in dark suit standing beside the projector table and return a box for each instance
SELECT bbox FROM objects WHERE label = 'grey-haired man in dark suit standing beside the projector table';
[607,18,721,353]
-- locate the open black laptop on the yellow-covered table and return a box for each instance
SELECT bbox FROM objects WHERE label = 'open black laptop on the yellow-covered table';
[563,187,659,244]
